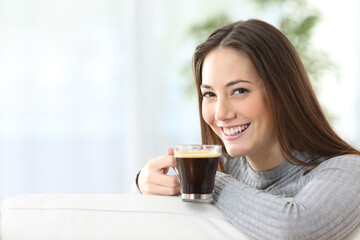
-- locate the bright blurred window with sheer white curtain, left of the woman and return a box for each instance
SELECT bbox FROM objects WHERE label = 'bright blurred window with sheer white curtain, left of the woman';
[0,0,128,200]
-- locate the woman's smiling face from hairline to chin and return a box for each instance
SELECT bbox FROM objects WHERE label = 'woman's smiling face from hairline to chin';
[200,48,278,158]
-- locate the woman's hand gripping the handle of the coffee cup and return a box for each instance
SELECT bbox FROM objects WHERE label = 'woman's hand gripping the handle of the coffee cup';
[138,148,180,195]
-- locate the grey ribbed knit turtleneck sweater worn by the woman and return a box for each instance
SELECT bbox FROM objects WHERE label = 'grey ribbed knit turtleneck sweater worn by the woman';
[132,152,360,240]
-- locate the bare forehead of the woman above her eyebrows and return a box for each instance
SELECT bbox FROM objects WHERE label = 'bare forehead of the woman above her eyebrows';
[202,47,260,85]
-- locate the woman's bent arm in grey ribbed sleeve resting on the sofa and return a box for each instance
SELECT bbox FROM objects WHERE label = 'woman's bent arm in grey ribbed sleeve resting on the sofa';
[214,156,360,240]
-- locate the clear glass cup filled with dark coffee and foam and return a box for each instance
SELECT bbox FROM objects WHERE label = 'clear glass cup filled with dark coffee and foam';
[174,145,221,202]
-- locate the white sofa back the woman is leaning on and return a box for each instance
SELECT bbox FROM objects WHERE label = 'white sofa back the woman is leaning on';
[0,194,360,240]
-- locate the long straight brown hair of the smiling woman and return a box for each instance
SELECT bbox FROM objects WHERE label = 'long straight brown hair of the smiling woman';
[193,19,360,171]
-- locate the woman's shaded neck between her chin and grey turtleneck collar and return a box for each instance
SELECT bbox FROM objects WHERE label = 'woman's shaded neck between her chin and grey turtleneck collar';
[246,143,286,172]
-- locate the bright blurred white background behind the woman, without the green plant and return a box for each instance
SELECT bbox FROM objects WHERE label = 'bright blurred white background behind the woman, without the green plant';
[0,0,360,201]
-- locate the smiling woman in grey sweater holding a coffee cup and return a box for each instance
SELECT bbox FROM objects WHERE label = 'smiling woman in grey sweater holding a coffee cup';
[137,20,360,239]
